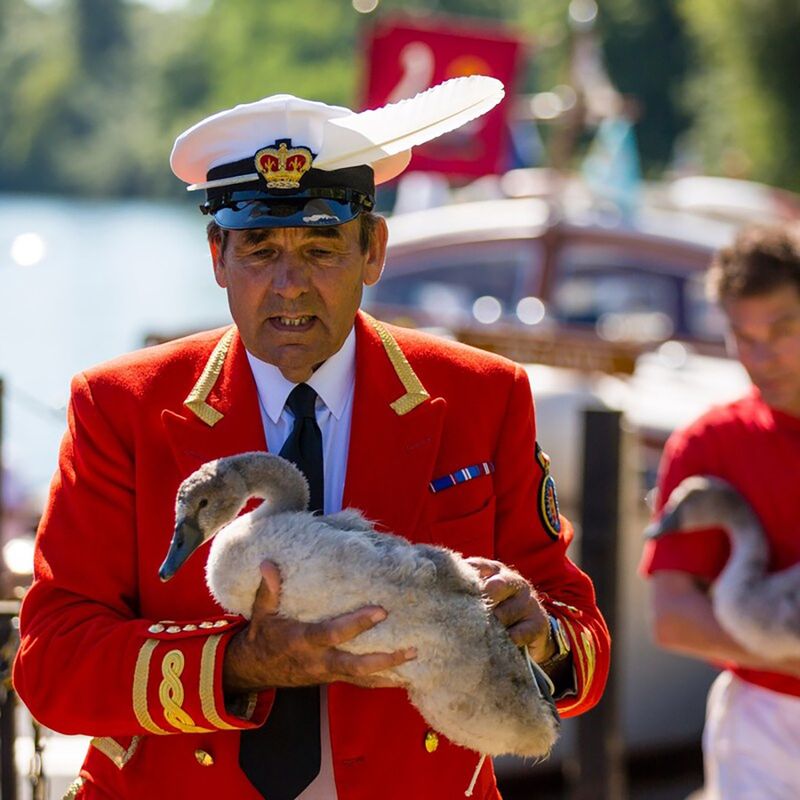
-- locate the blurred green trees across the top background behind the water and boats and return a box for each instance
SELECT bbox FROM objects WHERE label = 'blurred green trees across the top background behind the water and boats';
[0,0,800,196]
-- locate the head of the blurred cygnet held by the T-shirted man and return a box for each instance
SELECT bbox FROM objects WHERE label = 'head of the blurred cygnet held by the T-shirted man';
[644,475,752,539]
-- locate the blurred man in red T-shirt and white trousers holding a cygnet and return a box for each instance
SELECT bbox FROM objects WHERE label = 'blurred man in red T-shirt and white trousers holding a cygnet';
[642,227,800,800]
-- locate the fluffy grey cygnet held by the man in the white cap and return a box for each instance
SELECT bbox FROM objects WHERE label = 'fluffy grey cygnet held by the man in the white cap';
[162,453,559,756]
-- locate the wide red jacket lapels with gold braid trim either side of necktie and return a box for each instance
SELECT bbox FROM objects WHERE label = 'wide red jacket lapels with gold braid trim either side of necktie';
[161,312,446,536]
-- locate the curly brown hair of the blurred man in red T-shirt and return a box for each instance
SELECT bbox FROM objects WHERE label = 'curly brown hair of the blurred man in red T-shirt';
[706,223,800,302]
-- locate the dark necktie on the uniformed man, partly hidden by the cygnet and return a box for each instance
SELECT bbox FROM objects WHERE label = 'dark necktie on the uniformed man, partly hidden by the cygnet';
[239,383,324,800]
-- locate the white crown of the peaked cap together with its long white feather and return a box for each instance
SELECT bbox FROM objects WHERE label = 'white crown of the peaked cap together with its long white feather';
[170,75,505,189]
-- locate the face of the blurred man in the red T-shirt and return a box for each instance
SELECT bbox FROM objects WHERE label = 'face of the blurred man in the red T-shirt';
[722,284,800,415]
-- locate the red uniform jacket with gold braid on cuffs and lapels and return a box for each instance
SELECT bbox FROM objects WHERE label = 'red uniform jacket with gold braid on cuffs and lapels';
[14,314,609,800]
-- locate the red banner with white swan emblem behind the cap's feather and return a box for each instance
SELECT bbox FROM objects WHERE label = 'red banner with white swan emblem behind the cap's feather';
[364,18,523,177]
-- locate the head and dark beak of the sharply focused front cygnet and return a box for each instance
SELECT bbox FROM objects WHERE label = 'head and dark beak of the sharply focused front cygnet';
[158,459,249,581]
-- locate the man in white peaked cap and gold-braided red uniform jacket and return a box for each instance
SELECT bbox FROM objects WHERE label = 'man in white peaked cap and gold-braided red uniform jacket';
[14,79,609,800]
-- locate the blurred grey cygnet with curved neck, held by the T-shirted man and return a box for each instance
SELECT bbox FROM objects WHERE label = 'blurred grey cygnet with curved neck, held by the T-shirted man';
[647,475,800,659]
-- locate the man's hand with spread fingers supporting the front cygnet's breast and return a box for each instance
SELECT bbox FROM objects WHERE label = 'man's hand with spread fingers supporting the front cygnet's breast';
[223,561,416,693]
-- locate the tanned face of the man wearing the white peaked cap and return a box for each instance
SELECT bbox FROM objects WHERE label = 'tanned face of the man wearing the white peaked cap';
[211,219,386,383]
